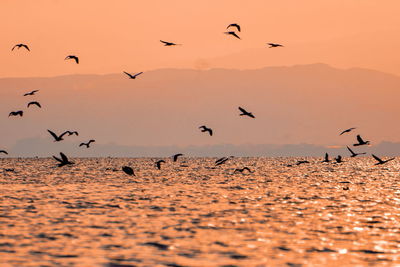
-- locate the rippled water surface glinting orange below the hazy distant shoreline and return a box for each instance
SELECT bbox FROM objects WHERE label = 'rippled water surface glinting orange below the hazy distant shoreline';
[0,158,400,267]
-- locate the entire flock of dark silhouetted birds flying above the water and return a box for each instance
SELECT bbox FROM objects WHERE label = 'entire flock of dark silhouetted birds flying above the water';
[0,23,395,176]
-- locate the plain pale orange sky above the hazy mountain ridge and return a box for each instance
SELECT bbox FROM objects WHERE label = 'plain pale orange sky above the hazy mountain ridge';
[0,0,400,77]
